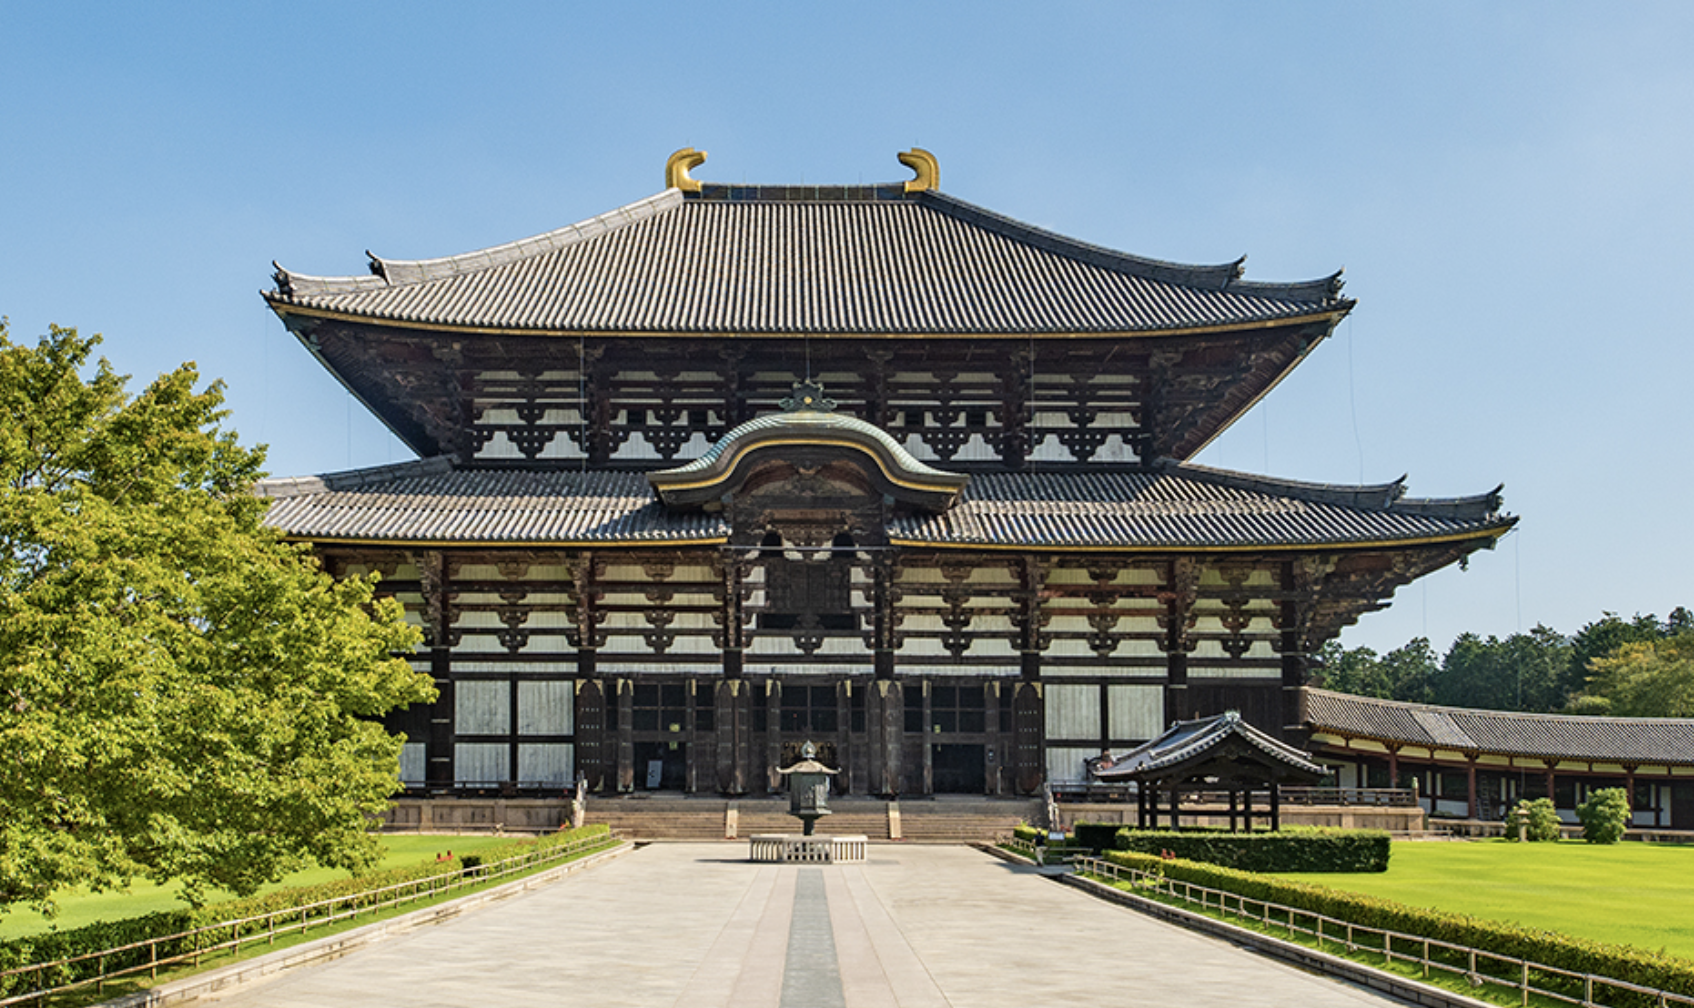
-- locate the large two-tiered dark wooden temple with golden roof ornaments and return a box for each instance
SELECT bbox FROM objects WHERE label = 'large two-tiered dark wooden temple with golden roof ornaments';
[259,151,1514,796]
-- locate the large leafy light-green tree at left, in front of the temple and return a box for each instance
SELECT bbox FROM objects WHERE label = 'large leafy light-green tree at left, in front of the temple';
[0,320,434,911]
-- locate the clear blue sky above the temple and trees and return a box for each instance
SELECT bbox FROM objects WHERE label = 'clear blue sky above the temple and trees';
[0,0,1694,649]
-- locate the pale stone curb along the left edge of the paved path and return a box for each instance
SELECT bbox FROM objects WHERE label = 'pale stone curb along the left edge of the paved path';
[97,840,635,1008]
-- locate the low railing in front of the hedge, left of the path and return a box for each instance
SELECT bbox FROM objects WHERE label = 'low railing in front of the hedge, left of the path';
[0,834,618,1006]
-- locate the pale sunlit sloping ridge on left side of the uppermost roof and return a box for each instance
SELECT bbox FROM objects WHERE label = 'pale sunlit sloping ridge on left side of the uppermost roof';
[271,190,683,296]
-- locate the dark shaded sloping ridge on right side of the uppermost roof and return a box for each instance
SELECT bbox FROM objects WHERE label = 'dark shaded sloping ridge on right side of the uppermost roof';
[915,190,1354,308]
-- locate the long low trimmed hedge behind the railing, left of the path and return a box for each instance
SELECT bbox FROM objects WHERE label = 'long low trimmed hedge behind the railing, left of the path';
[0,823,610,998]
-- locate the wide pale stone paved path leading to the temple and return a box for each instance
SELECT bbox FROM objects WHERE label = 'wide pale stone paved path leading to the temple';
[203,844,1392,1008]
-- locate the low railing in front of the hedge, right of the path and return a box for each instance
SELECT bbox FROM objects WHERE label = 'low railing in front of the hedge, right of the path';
[1074,857,1694,1008]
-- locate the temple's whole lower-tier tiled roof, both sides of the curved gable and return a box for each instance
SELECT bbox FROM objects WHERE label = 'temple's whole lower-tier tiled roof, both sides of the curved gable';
[257,457,1514,549]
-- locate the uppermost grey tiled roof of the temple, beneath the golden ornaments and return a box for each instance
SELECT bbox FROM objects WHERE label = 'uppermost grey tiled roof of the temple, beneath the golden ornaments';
[266,185,1352,335]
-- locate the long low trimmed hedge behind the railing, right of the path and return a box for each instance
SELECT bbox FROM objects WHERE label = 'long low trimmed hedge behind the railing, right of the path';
[1104,850,1694,1005]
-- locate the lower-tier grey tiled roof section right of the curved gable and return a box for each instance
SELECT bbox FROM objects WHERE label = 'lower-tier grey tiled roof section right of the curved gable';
[889,464,1514,547]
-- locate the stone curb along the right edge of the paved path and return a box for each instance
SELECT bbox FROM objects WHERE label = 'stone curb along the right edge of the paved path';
[977,844,1497,1008]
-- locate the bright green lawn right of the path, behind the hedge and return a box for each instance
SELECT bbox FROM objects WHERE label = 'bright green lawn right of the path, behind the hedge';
[1281,840,1694,959]
